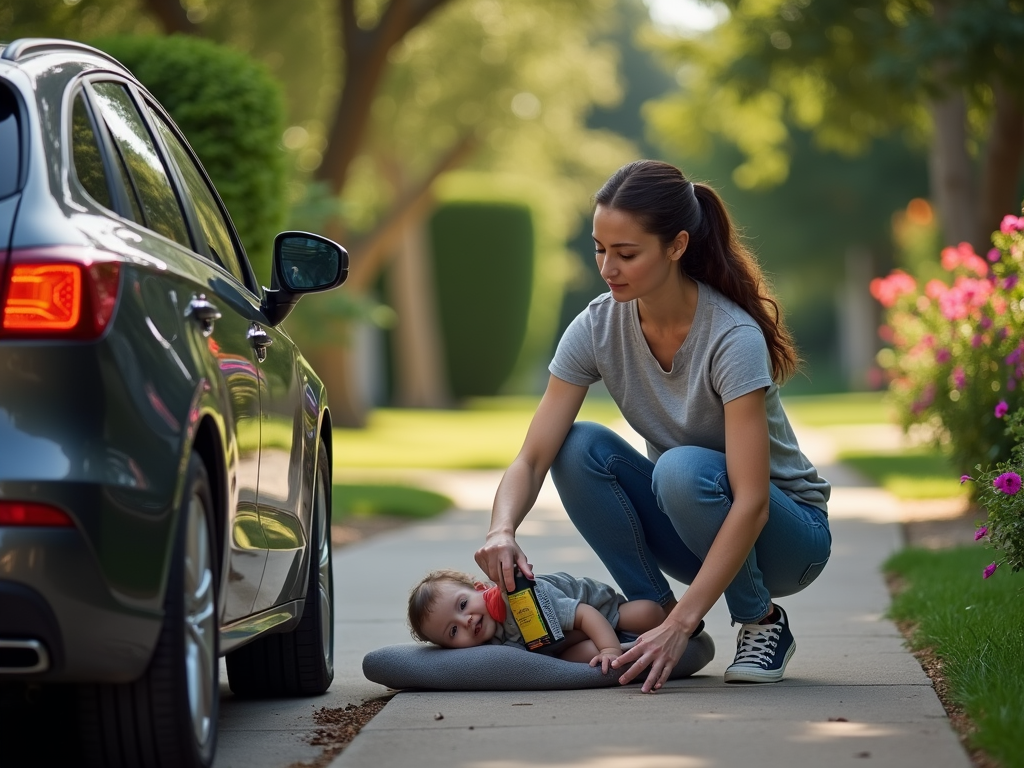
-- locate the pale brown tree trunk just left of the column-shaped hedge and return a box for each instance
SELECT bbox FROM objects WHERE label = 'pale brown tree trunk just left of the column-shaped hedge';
[388,220,452,408]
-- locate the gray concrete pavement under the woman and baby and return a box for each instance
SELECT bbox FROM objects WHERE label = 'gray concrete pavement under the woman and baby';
[331,423,970,768]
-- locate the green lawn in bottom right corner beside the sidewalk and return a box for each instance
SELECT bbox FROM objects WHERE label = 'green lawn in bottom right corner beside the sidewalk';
[886,544,1024,768]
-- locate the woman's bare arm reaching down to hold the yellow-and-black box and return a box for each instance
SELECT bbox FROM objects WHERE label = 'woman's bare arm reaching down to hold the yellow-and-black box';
[475,376,587,592]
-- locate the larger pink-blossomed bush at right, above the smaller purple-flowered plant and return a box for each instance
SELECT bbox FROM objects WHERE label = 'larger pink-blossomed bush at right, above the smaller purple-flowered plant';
[871,216,1024,467]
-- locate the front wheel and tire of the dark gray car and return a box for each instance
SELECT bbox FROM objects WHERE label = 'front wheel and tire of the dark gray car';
[225,442,334,696]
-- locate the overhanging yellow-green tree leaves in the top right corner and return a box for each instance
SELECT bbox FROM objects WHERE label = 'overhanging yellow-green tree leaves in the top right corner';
[650,0,1024,188]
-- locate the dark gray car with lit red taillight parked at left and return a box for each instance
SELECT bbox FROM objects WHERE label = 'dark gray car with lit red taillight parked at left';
[0,40,348,767]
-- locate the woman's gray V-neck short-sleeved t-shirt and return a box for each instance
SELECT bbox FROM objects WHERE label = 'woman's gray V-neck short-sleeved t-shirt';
[548,283,830,512]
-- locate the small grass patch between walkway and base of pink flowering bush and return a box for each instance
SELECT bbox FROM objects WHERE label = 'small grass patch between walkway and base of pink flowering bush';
[840,447,968,499]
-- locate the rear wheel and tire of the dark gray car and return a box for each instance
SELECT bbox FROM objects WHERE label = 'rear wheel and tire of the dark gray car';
[78,455,220,768]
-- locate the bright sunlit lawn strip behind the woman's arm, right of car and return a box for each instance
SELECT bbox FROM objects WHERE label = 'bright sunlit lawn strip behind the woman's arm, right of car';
[334,397,620,469]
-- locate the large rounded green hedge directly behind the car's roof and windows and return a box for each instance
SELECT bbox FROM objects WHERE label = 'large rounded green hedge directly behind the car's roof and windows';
[96,35,286,284]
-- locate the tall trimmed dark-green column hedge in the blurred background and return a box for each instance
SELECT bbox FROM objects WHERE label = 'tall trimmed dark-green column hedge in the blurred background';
[430,201,536,397]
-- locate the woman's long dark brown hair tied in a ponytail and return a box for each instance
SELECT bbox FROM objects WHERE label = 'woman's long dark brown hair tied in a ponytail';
[594,160,800,384]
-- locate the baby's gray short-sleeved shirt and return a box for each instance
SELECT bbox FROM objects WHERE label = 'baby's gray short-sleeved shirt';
[490,571,626,648]
